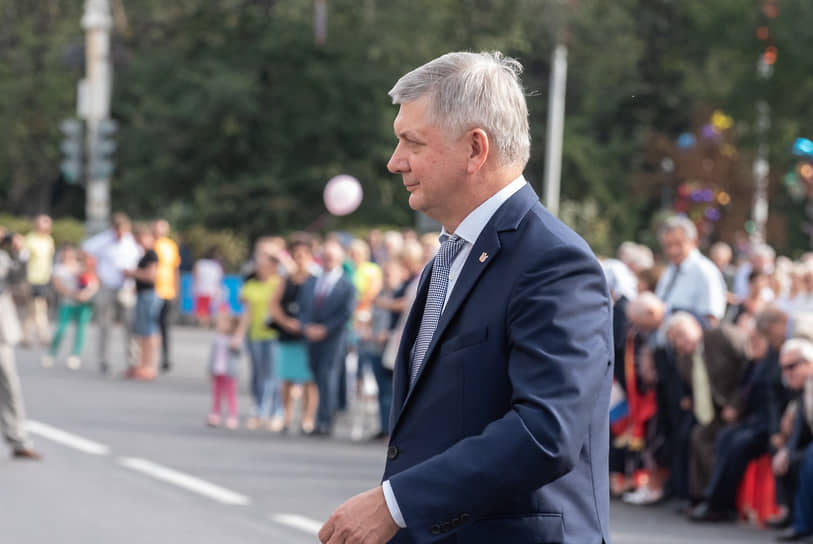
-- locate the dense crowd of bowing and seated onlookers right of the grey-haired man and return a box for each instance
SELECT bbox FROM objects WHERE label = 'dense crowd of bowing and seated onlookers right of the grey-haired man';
[602,216,813,541]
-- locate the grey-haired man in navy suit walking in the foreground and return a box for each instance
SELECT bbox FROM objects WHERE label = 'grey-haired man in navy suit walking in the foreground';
[319,53,613,544]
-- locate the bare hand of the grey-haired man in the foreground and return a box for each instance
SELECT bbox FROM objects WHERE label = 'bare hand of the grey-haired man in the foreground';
[319,486,398,544]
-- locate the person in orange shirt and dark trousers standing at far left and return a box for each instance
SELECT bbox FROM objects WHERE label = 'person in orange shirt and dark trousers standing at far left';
[153,219,181,372]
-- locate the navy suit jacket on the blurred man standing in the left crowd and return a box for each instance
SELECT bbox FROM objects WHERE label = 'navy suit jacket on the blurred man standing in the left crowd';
[299,275,356,362]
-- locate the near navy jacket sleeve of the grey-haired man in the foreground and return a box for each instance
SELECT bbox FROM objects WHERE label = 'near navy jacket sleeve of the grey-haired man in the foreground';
[390,246,613,536]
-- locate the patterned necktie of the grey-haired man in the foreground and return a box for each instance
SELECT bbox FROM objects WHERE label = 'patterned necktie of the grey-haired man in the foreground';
[409,236,465,387]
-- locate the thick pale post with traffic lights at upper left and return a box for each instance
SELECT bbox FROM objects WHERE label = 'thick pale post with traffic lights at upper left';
[79,0,113,236]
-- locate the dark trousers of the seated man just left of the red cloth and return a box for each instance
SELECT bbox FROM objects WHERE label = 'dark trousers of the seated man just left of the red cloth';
[704,423,770,510]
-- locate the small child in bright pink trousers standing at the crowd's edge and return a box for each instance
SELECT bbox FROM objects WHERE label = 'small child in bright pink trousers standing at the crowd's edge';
[207,310,240,429]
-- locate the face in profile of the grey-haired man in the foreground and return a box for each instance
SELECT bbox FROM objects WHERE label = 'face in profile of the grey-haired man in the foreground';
[387,97,468,223]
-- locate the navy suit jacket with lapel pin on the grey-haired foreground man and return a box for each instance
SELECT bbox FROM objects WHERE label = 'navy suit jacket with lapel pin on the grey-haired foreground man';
[384,185,613,544]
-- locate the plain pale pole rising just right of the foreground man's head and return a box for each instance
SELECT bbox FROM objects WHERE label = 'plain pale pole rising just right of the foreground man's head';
[545,44,567,215]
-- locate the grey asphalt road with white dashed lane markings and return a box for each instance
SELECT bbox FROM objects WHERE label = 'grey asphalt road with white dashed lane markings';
[0,328,773,544]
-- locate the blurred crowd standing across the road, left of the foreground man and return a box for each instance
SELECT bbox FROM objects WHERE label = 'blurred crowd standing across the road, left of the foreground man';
[0,213,438,454]
